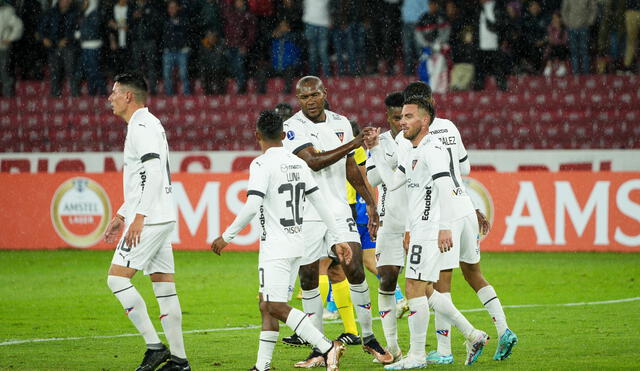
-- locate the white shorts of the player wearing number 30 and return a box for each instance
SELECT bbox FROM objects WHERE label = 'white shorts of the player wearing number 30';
[258,257,300,303]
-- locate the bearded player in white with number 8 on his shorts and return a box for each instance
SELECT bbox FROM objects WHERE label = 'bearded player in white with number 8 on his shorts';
[367,97,489,370]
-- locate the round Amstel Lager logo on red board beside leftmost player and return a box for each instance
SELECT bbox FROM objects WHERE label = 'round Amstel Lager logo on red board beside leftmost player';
[51,177,111,247]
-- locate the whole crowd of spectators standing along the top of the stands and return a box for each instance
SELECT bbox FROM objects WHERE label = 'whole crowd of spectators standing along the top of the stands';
[0,0,640,96]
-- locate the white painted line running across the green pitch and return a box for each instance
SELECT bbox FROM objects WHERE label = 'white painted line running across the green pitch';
[0,297,640,346]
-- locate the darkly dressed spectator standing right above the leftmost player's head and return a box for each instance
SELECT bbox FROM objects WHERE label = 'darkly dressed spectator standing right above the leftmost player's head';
[131,0,162,95]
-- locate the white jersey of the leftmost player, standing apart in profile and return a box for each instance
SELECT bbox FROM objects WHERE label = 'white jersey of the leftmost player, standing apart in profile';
[118,107,176,225]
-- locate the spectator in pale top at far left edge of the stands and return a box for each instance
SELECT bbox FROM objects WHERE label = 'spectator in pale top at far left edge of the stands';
[0,0,22,97]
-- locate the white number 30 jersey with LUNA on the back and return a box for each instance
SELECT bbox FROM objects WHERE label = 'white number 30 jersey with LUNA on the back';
[242,147,318,260]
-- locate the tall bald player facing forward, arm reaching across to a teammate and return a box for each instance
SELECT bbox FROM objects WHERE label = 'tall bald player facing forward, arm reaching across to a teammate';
[284,76,393,367]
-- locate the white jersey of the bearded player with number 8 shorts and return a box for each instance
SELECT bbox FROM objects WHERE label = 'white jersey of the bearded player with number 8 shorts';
[398,135,449,240]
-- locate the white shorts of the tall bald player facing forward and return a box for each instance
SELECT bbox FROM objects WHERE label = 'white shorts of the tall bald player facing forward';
[301,212,360,265]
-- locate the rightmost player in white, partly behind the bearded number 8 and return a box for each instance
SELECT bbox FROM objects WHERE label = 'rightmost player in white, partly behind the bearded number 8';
[404,82,518,364]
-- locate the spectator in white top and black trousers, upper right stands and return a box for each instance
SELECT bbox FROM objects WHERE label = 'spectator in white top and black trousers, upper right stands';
[474,0,507,91]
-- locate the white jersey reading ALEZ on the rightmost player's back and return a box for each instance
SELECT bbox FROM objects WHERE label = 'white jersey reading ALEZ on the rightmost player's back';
[429,117,475,220]
